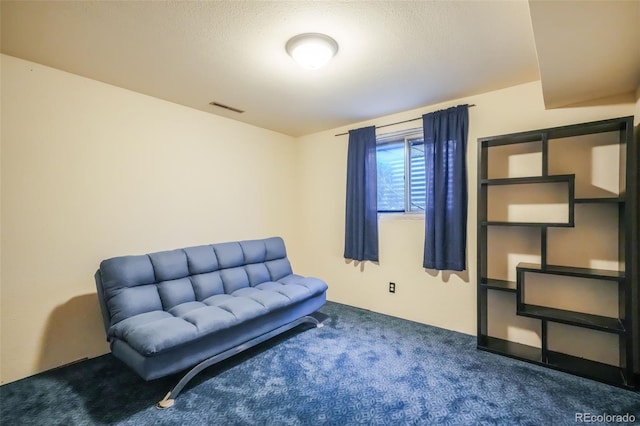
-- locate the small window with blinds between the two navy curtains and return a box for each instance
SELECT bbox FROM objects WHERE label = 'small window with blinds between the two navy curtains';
[376,129,426,213]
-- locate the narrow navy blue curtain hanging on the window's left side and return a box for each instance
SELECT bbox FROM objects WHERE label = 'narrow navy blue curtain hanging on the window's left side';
[344,126,378,261]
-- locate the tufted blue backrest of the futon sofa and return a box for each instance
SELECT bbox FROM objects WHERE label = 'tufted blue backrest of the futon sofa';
[96,237,292,334]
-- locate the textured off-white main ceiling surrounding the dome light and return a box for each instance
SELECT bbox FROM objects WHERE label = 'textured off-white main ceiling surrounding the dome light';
[1,0,636,136]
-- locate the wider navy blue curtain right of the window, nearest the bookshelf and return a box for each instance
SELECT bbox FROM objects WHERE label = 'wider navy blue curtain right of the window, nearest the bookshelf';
[422,105,469,271]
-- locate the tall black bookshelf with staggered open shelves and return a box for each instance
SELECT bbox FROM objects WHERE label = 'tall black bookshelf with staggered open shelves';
[477,117,640,389]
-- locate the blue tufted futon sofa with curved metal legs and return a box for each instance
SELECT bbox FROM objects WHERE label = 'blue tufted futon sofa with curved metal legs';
[95,237,327,408]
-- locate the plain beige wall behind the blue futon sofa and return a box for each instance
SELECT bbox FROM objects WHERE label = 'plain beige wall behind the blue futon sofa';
[0,56,295,383]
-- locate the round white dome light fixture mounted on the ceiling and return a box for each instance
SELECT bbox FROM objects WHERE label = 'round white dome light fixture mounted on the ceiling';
[285,33,338,70]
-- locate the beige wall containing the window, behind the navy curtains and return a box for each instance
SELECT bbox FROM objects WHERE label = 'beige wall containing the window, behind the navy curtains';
[295,82,634,360]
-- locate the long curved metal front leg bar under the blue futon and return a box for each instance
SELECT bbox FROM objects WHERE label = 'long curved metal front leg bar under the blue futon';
[156,315,323,409]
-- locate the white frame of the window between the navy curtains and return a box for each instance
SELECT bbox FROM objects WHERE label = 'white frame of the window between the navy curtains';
[376,127,426,216]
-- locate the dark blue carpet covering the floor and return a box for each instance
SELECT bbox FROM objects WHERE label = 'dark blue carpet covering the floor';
[0,303,640,426]
